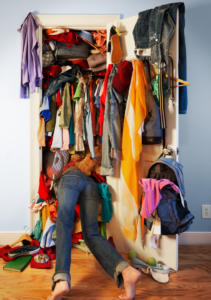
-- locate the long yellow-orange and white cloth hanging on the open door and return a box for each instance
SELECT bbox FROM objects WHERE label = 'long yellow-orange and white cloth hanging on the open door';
[121,60,148,242]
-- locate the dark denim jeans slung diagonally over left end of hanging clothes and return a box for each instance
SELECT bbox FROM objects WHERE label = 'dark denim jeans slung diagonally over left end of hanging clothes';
[43,65,79,96]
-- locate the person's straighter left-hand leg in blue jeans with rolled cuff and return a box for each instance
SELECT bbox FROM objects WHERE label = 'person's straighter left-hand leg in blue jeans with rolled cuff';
[50,171,82,299]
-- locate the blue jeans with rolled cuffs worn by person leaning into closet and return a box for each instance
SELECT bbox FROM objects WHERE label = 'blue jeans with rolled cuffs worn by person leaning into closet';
[52,170,129,290]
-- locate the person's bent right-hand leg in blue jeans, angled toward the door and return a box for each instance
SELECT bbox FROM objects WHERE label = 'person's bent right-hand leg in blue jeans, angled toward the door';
[79,177,129,287]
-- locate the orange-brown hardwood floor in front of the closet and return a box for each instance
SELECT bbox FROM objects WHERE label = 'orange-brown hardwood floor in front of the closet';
[0,246,211,300]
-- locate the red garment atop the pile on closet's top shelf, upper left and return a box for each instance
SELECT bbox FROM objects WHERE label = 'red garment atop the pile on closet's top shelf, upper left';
[44,31,83,48]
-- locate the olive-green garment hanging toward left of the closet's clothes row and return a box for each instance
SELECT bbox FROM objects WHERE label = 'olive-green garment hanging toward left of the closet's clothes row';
[59,82,72,129]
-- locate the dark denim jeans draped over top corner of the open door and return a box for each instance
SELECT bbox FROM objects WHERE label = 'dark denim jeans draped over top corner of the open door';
[133,2,188,114]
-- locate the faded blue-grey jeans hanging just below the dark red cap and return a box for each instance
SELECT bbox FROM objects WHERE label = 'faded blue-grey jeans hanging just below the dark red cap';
[101,66,123,175]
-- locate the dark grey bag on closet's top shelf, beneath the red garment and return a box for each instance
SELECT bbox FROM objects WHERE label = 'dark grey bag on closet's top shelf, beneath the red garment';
[55,41,89,59]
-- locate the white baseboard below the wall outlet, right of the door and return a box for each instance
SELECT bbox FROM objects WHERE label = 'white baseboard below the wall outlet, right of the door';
[179,232,211,245]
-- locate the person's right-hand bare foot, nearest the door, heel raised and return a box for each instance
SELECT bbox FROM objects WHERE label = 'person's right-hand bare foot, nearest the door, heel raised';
[119,266,141,300]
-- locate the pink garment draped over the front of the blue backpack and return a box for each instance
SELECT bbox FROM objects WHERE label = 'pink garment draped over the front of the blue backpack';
[139,178,180,218]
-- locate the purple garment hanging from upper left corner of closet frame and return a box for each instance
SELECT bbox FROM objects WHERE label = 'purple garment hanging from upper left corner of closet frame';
[18,13,43,98]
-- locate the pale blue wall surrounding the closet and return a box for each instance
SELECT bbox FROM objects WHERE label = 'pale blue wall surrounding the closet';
[0,0,211,233]
